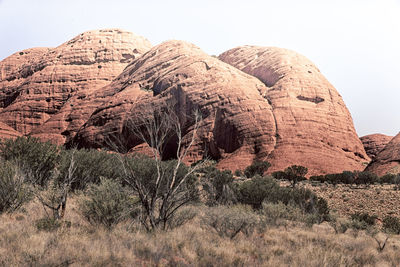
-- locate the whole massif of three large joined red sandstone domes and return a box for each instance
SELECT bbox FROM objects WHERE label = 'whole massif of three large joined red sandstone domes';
[0,30,369,175]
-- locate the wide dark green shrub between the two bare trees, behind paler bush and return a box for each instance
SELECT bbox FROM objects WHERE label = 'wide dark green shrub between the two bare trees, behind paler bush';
[58,149,122,190]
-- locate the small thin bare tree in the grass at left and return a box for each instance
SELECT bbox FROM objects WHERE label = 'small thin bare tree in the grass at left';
[37,150,76,220]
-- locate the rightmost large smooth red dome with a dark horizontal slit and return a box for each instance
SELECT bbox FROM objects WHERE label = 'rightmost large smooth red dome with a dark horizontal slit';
[219,46,369,174]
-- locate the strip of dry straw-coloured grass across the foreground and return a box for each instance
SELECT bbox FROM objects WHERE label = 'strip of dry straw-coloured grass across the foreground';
[0,197,400,266]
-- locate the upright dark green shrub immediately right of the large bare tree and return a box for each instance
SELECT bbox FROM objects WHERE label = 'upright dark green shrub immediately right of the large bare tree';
[203,167,235,206]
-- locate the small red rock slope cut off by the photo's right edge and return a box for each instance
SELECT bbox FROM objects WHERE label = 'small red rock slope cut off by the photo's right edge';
[365,133,400,175]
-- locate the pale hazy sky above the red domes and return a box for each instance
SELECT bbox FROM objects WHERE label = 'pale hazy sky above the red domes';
[0,0,400,136]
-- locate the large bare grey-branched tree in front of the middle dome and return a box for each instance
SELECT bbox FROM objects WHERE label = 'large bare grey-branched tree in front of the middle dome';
[120,109,204,231]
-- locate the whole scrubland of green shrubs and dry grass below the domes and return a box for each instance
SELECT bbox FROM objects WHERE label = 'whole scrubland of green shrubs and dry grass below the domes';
[0,138,400,266]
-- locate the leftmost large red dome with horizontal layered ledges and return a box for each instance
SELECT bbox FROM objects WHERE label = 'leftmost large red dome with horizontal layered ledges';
[0,29,151,134]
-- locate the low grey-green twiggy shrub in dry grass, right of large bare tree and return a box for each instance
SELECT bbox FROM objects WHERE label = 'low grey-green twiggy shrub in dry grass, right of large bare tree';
[202,205,259,239]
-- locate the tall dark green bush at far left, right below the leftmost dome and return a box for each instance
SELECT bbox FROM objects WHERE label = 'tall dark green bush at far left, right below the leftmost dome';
[0,137,60,186]
